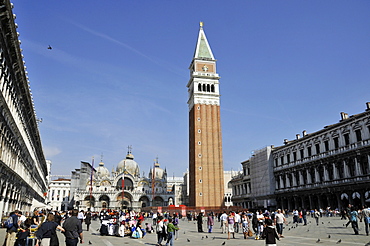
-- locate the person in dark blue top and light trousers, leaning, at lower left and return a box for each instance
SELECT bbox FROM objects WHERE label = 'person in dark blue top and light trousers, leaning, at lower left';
[35,213,64,246]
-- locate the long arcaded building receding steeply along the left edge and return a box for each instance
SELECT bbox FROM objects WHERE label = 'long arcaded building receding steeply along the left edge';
[0,0,49,218]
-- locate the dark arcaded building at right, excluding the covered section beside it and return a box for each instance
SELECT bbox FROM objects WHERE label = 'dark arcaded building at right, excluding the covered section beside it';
[272,103,370,209]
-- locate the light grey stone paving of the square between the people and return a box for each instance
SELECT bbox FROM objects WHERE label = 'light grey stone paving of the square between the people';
[0,217,370,246]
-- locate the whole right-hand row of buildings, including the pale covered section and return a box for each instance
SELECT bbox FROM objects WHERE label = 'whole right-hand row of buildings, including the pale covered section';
[231,103,370,210]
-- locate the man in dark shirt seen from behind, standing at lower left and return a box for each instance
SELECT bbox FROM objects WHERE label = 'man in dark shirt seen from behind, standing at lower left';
[63,209,83,246]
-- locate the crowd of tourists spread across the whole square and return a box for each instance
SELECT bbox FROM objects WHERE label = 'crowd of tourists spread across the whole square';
[3,205,370,246]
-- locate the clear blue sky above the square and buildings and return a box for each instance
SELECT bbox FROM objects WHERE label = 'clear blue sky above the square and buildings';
[13,0,370,176]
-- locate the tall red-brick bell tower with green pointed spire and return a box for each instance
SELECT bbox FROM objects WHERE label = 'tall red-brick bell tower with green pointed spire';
[187,22,224,207]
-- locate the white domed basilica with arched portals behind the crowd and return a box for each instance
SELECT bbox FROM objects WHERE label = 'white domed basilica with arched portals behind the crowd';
[70,151,176,211]
